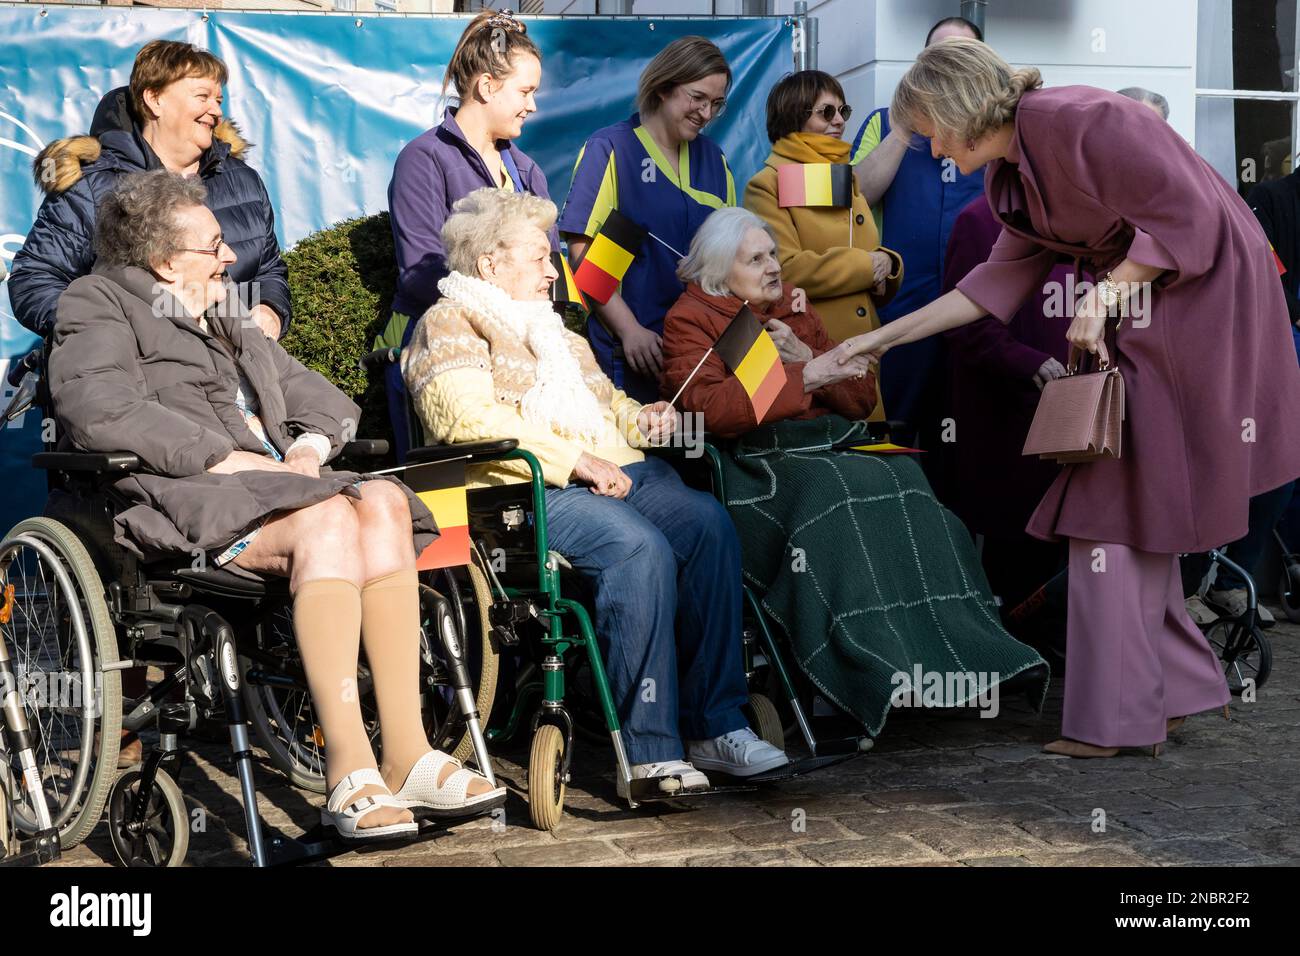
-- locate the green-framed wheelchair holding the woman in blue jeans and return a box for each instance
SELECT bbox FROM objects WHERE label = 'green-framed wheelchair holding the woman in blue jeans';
[359,349,872,830]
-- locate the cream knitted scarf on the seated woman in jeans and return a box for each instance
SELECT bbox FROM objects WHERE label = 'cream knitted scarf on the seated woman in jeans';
[438,272,606,442]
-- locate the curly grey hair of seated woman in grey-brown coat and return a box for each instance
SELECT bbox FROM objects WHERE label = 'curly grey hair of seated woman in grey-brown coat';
[95,169,208,269]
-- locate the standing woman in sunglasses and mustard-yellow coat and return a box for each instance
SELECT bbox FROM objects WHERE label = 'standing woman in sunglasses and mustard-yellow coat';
[745,70,902,420]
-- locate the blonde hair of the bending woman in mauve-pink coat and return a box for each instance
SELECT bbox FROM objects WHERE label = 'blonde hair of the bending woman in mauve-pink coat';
[889,36,1043,140]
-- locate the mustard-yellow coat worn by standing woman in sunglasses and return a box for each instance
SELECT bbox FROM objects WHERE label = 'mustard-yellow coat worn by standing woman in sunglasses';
[745,133,902,351]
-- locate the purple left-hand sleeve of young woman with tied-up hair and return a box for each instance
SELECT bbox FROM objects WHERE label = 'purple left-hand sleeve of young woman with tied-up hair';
[389,144,449,319]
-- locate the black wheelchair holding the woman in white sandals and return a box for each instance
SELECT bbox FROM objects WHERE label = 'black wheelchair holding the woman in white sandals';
[0,349,493,866]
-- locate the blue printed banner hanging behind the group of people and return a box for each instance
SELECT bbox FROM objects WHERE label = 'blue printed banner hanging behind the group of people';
[0,4,793,533]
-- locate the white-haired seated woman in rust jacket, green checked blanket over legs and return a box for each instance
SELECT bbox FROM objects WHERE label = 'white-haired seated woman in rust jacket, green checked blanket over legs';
[663,208,1048,736]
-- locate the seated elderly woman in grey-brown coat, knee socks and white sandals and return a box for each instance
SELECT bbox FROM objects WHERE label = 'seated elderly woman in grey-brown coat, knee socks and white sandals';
[48,170,504,840]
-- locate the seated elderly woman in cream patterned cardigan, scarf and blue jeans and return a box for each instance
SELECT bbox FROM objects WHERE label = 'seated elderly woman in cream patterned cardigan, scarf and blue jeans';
[402,189,788,797]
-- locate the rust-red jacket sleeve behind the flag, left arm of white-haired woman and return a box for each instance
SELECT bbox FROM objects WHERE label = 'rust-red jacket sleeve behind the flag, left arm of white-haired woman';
[663,299,813,438]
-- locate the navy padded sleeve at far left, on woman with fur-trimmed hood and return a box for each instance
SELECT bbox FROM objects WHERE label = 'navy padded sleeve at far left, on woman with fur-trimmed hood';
[9,178,95,338]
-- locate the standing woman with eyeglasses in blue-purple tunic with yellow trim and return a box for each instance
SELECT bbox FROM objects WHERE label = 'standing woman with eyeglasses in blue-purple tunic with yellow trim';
[559,36,736,402]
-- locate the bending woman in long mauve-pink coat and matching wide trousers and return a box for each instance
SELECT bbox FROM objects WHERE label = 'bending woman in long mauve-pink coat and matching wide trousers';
[844,39,1300,757]
